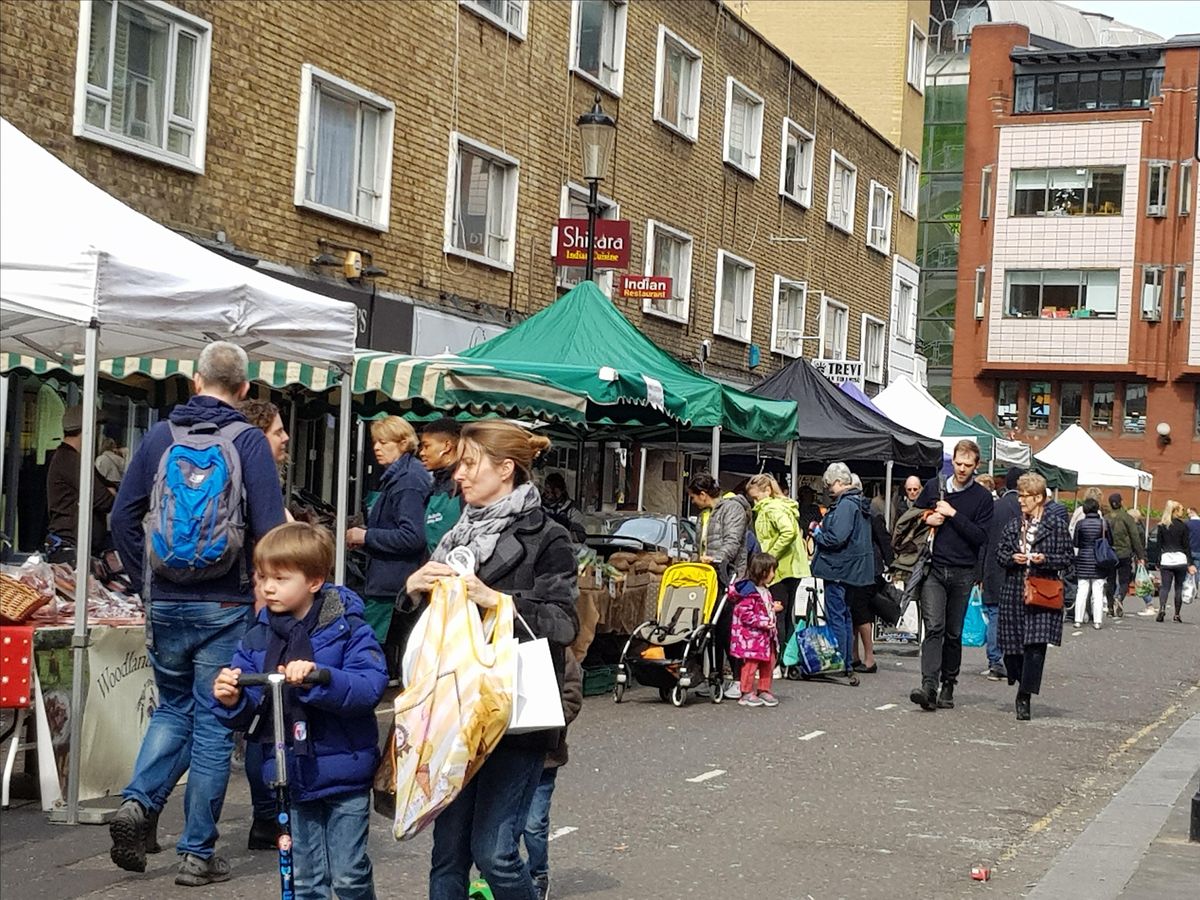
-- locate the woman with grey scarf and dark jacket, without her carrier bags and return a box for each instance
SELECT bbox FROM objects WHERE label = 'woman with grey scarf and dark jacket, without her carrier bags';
[407,421,578,900]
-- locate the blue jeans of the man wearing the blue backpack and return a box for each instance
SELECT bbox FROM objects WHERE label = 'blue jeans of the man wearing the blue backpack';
[121,601,253,859]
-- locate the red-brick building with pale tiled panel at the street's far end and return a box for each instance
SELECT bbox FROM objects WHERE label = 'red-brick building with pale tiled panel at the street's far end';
[952,24,1200,502]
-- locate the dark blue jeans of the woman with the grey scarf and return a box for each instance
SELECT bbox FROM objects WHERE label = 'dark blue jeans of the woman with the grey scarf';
[428,744,546,900]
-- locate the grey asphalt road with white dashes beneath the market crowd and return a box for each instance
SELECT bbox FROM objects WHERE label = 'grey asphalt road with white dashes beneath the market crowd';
[0,607,1200,900]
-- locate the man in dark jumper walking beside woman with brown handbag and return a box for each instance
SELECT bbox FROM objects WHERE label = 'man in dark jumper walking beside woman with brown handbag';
[908,440,995,710]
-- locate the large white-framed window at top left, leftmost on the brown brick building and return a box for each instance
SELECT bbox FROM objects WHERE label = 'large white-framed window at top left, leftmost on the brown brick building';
[74,0,212,173]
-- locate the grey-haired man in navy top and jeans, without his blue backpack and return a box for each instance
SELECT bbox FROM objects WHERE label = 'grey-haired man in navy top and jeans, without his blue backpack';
[109,341,284,887]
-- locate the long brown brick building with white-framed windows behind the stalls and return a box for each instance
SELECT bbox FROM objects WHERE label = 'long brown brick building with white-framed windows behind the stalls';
[0,0,916,388]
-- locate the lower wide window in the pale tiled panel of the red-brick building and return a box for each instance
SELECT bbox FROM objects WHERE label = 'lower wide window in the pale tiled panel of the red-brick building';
[1004,269,1120,319]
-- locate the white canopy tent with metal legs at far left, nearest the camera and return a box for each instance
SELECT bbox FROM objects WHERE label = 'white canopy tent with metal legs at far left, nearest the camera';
[0,119,356,823]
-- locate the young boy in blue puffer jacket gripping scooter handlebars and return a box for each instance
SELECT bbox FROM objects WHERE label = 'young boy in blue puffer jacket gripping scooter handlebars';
[212,522,388,900]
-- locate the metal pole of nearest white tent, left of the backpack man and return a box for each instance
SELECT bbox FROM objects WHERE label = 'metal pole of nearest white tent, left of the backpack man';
[67,322,100,824]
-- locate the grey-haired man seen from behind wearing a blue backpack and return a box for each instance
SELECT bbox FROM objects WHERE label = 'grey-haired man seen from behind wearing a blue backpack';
[109,341,284,887]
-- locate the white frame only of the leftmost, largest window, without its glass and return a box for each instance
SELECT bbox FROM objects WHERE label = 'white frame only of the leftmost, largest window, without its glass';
[72,0,212,175]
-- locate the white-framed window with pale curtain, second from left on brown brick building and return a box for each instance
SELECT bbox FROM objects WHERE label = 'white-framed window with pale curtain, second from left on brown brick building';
[295,64,395,230]
